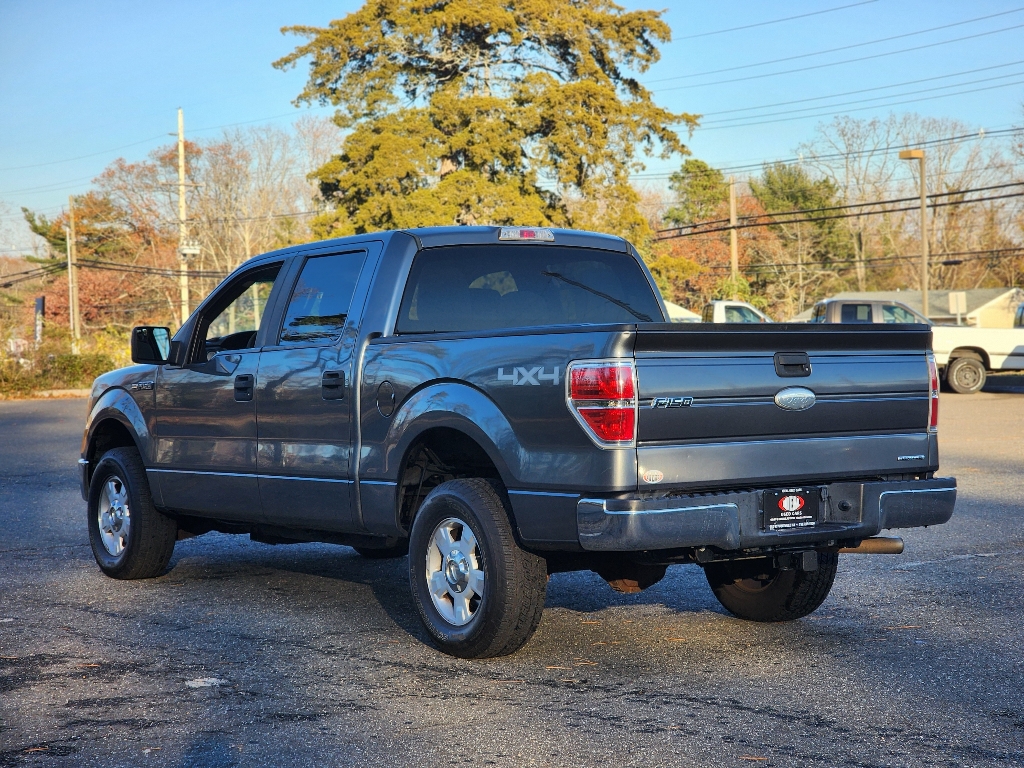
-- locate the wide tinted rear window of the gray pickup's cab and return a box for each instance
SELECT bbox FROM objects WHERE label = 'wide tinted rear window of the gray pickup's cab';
[395,245,665,333]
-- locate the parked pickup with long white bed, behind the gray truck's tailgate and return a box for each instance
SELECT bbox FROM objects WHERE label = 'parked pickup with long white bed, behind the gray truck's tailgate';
[810,299,1024,394]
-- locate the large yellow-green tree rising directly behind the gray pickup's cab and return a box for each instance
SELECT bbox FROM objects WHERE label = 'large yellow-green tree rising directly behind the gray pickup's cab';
[275,0,696,244]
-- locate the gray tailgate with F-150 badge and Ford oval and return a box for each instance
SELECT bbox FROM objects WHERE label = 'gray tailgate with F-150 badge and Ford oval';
[635,325,938,489]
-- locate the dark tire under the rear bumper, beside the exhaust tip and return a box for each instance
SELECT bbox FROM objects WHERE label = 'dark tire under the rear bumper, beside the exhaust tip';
[705,552,839,622]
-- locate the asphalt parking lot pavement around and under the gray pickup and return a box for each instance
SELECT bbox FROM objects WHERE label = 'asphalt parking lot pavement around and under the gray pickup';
[0,387,1024,767]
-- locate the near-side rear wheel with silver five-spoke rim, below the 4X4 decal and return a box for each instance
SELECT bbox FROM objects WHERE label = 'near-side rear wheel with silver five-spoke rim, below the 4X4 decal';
[409,479,548,658]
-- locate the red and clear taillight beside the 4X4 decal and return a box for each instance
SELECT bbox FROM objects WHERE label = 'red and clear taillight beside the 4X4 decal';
[565,360,637,447]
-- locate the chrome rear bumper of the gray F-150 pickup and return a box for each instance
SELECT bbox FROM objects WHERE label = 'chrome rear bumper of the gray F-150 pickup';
[577,477,956,552]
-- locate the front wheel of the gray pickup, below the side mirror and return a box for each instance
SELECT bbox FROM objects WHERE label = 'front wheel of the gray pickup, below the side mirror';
[87,447,178,579]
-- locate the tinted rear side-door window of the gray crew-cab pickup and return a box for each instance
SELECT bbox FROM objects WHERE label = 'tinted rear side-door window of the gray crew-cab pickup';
[280,251,366,344]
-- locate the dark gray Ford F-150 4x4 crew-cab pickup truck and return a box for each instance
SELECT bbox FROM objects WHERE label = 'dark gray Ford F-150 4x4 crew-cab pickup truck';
[80,227,956,657]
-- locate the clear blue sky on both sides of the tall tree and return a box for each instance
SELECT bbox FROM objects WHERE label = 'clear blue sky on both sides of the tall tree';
[0,0,1024,251]
